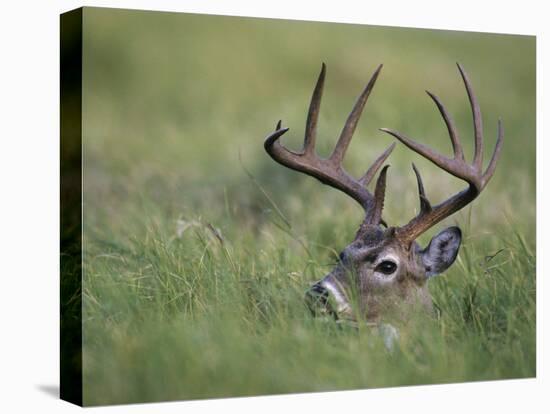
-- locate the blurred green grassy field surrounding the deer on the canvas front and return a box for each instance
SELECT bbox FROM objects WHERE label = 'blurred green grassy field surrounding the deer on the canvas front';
[83,9,536,405]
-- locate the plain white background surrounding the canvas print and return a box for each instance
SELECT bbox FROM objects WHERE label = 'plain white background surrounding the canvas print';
[0,0,550,414]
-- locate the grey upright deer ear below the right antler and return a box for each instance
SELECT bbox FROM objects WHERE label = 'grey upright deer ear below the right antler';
[420,227,462,277]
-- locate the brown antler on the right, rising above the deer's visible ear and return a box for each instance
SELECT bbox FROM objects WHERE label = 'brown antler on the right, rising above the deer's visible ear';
[381,63,503,242]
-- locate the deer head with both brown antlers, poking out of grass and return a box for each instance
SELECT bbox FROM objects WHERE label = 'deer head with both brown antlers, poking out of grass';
[264,64,503,322]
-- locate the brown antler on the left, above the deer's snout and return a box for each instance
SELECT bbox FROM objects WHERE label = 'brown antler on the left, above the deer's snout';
[264,63,395,225]
